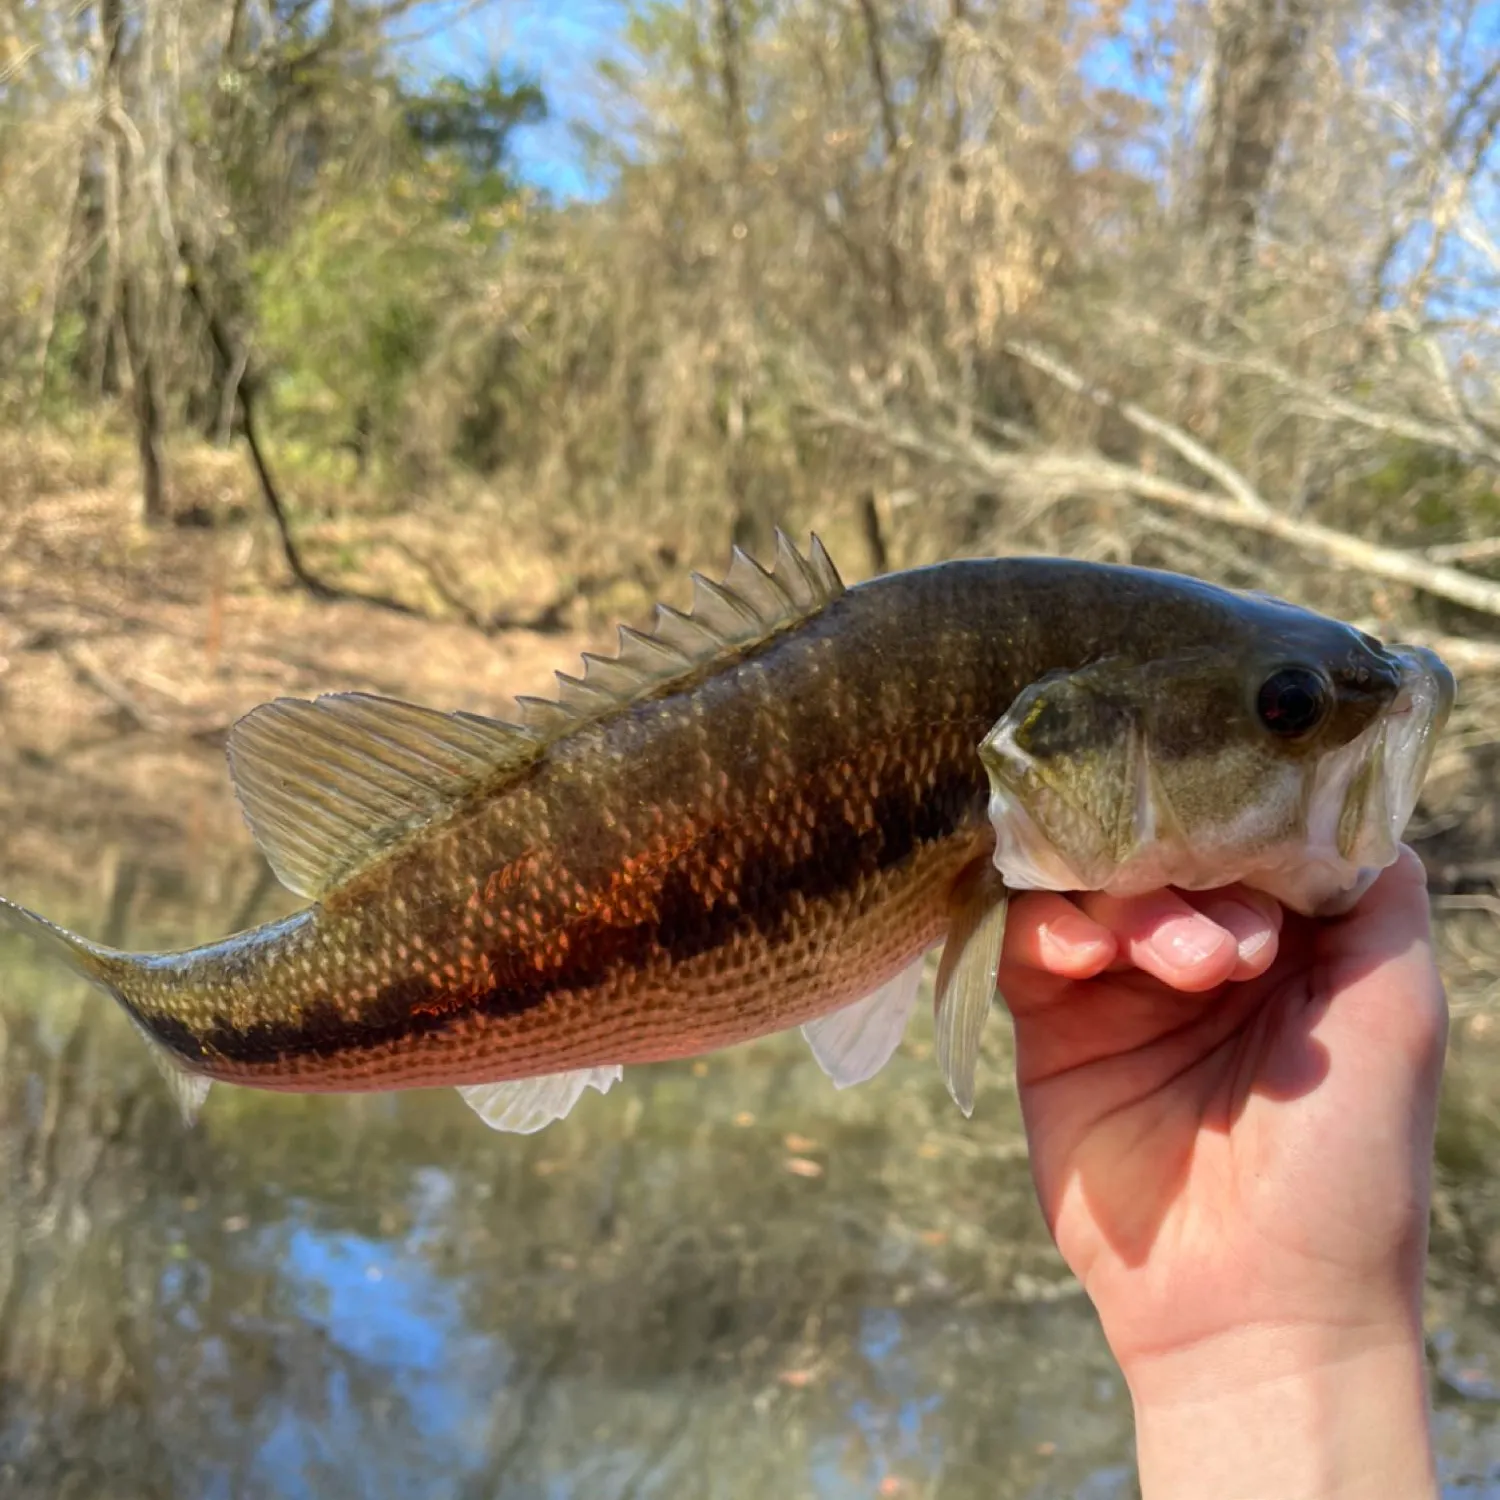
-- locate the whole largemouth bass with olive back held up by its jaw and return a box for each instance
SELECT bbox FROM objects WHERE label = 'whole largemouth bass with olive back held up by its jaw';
[0,533,1457,1133]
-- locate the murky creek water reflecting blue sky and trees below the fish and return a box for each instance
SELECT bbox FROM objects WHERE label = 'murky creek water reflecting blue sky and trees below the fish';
[0,872,1500,1500]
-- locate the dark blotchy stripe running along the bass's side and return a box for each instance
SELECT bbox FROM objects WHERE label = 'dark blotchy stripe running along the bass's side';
[158,764,986,1067]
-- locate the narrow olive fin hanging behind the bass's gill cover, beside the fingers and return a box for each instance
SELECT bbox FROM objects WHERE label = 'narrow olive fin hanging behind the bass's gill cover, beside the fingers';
[936,860,1007,1116]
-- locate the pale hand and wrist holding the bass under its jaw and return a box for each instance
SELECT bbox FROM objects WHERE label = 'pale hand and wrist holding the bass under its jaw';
[1001,851,1448,1500]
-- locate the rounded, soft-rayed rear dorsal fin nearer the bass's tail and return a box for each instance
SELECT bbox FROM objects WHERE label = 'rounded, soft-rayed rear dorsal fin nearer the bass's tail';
[230,693,539,899]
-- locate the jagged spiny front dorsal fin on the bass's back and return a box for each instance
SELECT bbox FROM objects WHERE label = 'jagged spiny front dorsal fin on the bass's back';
[518,530,843,738]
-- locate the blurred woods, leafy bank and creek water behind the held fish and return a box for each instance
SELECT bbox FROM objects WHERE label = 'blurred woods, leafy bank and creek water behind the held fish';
[0,0,1500,1500]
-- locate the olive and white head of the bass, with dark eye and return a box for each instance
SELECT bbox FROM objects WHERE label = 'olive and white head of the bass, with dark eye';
[980,591,1455,915]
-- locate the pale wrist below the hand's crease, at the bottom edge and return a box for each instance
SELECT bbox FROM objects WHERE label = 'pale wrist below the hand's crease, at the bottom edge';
[1127,1319,1437,1500]
